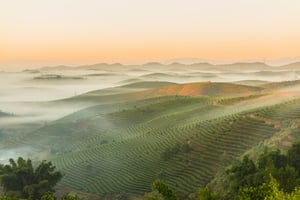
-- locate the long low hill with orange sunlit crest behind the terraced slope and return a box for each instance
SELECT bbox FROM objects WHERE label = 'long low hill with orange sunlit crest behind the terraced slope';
[58,82,264,103]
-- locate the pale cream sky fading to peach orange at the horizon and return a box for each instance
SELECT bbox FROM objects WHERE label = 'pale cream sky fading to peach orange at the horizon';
[0,0,300,69]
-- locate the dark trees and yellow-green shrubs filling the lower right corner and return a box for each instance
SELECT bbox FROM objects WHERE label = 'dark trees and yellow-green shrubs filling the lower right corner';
[149,143,300,200]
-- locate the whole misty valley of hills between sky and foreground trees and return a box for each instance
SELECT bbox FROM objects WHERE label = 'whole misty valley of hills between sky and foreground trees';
[0,63,300,199]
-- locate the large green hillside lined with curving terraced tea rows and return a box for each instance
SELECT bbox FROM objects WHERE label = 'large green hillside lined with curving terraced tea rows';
[41,97,300,195]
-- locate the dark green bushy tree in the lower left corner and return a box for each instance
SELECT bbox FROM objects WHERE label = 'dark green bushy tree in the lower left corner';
[0,157,62,199]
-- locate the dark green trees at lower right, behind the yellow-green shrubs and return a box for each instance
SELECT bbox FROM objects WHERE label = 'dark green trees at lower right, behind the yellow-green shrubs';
[226,143,300,199]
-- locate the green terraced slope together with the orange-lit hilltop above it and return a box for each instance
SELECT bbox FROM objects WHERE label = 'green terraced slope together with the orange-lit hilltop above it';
[4,80,300,194]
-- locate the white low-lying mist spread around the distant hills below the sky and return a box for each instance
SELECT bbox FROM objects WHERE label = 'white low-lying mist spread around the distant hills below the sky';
[0,65,300,163]
